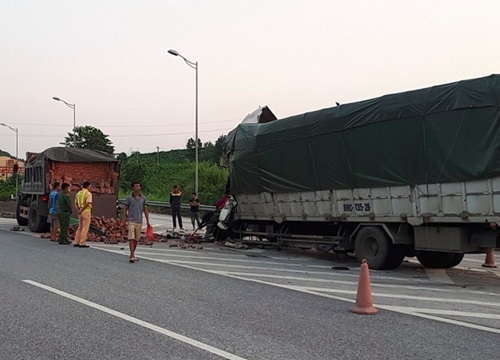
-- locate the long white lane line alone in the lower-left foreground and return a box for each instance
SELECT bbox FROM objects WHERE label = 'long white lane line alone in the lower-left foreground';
[23,280,249,360]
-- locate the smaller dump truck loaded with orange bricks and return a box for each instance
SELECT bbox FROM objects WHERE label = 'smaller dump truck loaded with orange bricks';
[16,147,120,232]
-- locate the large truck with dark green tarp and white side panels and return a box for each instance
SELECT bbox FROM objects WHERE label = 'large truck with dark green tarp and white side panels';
[220,75,500,269]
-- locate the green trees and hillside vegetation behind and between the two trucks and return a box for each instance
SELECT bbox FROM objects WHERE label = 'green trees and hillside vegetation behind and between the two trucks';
[61,126,228,205]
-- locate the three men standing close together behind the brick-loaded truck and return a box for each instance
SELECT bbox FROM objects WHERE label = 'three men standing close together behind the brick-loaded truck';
[49,181,92,248]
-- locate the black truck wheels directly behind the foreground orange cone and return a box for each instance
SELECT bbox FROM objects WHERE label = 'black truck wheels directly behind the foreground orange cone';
[354,226,405,270]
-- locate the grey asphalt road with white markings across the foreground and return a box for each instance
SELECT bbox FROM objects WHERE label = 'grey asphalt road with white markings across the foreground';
[0,219,500,360]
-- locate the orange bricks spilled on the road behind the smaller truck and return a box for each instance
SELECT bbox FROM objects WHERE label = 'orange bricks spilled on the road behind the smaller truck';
[41,216,164,245]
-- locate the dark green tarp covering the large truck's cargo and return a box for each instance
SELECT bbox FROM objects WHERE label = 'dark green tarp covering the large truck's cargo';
[226,75,500,194]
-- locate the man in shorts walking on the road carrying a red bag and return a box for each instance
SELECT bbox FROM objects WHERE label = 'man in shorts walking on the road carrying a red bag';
[122,181,151,263]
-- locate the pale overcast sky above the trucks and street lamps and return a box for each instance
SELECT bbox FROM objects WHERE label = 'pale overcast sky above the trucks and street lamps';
[0,0,500,156]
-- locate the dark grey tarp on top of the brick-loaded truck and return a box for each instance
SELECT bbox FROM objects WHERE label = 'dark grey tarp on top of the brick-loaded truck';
[28,146,118,164]
